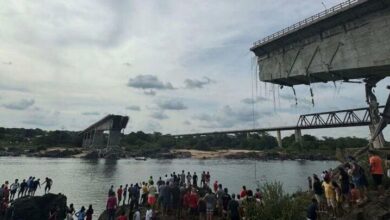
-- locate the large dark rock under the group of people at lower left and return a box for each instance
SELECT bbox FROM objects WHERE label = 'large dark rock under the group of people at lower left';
[4,193,66,220]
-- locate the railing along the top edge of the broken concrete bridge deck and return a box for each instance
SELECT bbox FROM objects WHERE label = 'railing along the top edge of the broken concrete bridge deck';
[253,0,367,47]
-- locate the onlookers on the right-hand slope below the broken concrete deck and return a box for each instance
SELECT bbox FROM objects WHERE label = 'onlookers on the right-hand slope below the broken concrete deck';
[307,151,384,220]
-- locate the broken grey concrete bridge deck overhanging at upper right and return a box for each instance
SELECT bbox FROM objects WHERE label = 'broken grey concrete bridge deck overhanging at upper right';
[251,0,390,86]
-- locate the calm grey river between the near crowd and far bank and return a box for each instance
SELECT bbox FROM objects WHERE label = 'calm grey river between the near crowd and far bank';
[0,157,339,216]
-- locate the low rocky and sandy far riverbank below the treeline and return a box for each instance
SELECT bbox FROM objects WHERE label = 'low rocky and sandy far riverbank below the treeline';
[0,147,336,160]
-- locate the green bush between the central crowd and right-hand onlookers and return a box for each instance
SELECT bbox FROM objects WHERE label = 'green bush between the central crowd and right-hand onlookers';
[244,182,310,220]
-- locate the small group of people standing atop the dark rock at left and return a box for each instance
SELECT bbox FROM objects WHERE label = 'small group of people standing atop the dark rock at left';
[0,176,53,216]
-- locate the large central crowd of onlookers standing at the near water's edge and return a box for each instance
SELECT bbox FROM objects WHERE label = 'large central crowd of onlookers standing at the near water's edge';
[102,170,261,220]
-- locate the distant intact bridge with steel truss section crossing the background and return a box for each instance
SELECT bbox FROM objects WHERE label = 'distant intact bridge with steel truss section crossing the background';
[174,106,385,147]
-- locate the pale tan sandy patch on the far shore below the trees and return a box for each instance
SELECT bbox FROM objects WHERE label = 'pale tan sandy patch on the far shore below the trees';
[171,149,262,159]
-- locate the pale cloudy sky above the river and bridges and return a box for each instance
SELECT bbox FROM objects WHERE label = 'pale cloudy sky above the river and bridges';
[0,0,389,137]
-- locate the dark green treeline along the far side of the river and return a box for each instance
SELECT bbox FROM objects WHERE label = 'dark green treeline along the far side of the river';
[0,127,368,151]
